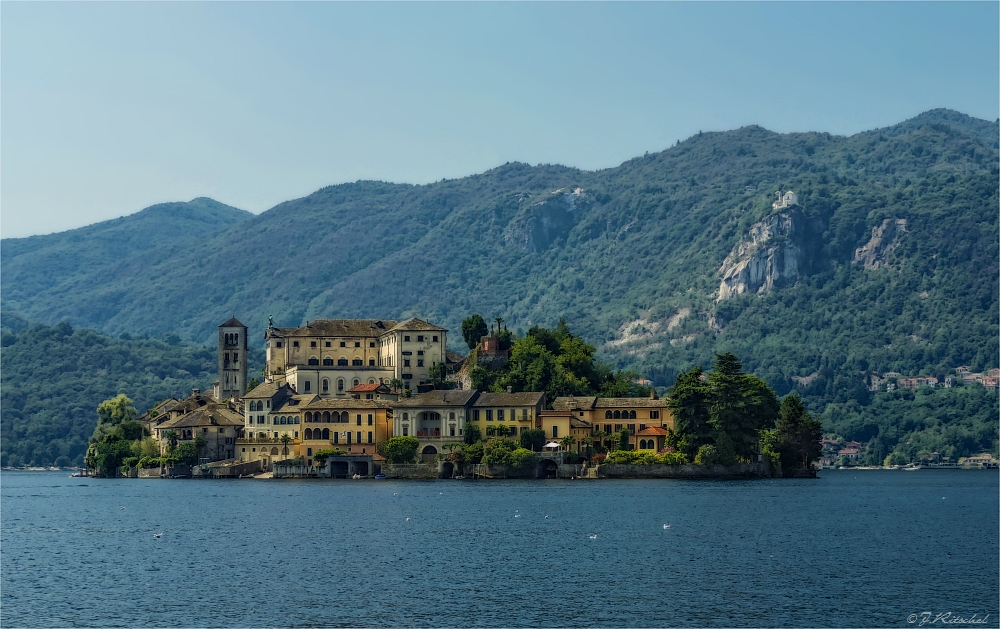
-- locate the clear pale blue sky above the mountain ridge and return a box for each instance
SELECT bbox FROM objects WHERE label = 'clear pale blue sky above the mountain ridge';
[0,2,1000,237]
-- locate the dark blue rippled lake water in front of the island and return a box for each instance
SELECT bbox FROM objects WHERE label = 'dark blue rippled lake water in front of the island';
[0,470,1000,627]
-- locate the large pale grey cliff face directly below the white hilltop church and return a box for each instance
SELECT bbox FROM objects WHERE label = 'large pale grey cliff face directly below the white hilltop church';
[717,212,803,301]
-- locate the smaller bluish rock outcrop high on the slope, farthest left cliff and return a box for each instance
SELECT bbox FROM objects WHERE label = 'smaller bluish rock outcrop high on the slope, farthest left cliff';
[504,188,595,252]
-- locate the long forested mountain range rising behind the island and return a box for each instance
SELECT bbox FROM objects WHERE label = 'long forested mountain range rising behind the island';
[0,110,1000,462]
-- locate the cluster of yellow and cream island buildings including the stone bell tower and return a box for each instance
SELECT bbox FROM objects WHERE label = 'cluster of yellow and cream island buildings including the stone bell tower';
[138,317,674,476]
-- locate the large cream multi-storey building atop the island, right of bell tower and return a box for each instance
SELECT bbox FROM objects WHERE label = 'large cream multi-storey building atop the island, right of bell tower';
[264,319,448,398]
